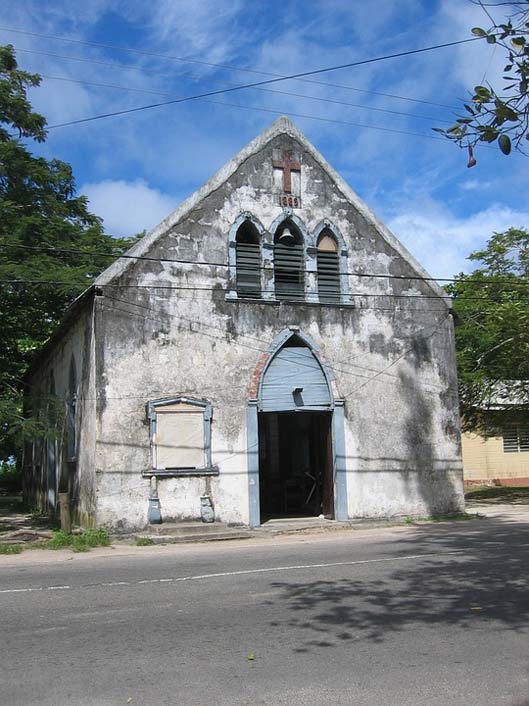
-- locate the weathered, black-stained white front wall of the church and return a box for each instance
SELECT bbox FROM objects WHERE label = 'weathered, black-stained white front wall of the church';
[96,125,463,529]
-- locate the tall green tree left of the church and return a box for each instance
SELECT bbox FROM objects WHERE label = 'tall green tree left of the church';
[0,45,133,459]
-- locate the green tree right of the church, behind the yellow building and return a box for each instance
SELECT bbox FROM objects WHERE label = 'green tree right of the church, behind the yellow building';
[447,228,529,430]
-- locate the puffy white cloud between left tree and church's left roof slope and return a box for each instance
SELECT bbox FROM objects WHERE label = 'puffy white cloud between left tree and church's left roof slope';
[80,179,178,236]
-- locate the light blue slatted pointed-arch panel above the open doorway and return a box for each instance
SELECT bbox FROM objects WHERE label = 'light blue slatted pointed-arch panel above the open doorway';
[259,347,332,412]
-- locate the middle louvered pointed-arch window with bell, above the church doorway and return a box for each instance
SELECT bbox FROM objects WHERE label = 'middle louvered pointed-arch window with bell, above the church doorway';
[274,220,305,299]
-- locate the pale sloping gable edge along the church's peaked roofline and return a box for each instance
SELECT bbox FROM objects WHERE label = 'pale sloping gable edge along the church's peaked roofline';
[94,115,448,302]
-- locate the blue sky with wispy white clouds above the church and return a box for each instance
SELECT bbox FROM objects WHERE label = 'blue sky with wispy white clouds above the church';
[0,0,529,277]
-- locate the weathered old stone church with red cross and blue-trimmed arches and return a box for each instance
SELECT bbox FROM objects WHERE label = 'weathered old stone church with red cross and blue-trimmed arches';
[25,117,463,532]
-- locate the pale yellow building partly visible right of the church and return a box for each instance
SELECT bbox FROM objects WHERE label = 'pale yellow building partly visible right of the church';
[461,423,529,485]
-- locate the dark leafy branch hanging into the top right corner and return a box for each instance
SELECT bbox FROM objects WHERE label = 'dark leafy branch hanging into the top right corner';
[434,0,529,160]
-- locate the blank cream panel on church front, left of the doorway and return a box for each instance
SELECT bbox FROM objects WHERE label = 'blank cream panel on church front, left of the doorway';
[148,397,211,474]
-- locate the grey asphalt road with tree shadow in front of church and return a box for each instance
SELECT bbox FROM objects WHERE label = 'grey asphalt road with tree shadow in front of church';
[0,516,529,706]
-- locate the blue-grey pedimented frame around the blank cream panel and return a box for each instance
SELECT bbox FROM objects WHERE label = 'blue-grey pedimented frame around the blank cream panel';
[143,396,219,478]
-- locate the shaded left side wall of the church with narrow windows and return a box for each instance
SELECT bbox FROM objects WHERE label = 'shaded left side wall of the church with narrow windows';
[24,298,96,526]
